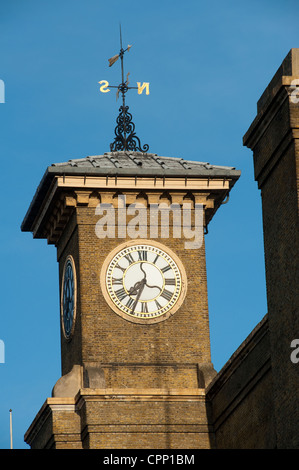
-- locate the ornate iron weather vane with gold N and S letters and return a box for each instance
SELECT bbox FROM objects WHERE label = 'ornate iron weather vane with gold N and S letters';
[98,26,149,152]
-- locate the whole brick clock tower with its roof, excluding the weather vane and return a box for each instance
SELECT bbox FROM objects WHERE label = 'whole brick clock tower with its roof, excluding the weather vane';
[22,150,240,449]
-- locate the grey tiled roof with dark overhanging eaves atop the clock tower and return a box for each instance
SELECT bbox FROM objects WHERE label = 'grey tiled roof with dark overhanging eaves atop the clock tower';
[21,151,241,237]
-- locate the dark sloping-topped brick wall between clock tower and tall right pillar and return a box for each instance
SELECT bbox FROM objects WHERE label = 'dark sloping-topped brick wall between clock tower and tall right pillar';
[207,316,276,449]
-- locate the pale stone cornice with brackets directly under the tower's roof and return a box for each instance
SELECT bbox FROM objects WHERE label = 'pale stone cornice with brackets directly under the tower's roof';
[22,175,235,245]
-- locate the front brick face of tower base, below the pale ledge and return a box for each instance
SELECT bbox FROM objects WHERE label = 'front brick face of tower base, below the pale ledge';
[81,389,214,449]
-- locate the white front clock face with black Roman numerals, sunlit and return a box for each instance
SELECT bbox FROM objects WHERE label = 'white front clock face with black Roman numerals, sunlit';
[103,242,186,323]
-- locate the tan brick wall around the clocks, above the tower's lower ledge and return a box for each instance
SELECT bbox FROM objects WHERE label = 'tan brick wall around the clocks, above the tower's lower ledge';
[58,196,211,387]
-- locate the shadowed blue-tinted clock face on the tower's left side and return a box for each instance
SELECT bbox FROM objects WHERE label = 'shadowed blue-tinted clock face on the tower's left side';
[61,256,76,339]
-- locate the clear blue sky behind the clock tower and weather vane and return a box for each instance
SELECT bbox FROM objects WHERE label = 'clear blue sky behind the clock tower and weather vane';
[0,0,299,448]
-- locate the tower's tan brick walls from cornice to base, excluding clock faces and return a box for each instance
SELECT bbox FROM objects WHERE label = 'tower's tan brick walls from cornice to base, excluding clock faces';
[27,177,236,448]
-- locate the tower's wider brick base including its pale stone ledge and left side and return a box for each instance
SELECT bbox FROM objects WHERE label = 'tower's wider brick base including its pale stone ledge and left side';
[25,388,215,449]
